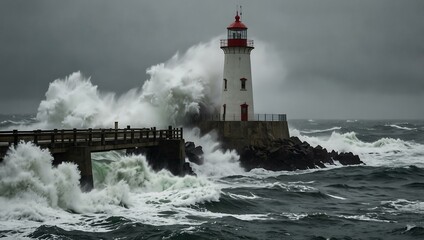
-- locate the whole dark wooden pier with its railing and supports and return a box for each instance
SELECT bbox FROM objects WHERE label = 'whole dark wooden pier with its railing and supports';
[0,126,185,189]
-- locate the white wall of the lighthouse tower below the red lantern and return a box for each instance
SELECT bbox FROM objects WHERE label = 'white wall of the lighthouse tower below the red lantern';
[220,47,254,121]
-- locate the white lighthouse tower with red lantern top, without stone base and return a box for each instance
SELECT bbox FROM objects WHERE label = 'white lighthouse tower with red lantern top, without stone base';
[220,11,254,121]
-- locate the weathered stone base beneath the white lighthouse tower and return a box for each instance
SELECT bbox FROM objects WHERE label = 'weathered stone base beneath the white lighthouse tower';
[198,121,290,152]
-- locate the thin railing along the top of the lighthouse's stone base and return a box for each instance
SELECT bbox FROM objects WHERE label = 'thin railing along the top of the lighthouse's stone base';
[199,113,287,122]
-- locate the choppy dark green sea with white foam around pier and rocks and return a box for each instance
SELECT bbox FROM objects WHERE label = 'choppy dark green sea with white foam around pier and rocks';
[0,115,424,239]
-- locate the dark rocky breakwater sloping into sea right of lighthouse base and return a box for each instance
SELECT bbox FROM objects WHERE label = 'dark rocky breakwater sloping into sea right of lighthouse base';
[240,137,364,171]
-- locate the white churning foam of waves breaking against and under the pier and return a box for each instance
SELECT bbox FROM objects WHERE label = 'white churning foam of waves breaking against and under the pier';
[0,143,221,237]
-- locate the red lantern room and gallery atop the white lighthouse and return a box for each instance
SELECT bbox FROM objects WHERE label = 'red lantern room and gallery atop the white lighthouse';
[221,12,253,48]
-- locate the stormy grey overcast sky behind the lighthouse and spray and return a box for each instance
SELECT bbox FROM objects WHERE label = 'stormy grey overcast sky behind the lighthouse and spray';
[0,0,424,119]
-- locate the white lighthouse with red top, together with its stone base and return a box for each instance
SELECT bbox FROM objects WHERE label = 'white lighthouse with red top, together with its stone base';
[197,11,290,153]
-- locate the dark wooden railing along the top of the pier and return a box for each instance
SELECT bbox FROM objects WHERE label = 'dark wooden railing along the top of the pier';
[0,126,183,148]
